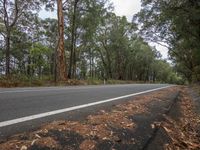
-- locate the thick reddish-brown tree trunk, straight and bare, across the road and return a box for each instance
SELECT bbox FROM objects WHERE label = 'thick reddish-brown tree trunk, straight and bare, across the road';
[57,0,67,81]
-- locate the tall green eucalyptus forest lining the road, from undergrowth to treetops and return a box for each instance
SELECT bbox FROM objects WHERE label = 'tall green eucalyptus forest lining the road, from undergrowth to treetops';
[0,0,200,84]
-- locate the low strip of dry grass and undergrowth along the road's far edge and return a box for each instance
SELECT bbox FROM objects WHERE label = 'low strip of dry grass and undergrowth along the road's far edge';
[0,75,148,88]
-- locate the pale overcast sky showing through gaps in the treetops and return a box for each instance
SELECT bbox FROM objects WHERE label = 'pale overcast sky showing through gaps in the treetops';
[39,0,168,59]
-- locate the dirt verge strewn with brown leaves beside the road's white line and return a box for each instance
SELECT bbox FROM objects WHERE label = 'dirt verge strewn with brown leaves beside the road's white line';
[0,86,200,150]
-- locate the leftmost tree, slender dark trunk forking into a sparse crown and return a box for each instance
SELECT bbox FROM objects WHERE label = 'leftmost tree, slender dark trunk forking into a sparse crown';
[0,0,40,75]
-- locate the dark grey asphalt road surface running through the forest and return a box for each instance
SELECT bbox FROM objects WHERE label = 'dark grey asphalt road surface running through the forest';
[0,84,169,136]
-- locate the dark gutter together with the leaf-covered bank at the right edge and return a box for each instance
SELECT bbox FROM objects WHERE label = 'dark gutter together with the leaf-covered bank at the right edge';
[145,87,200,150]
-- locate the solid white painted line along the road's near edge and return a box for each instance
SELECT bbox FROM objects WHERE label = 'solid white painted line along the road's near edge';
[0,85,173,127]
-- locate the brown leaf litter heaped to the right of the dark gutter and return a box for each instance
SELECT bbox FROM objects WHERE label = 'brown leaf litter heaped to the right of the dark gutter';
[160,87,200,150]
